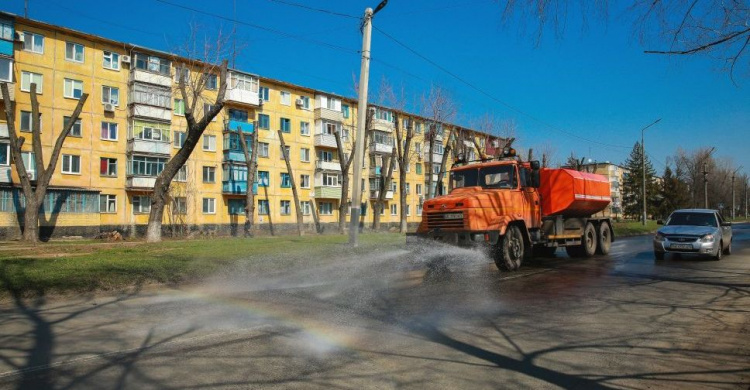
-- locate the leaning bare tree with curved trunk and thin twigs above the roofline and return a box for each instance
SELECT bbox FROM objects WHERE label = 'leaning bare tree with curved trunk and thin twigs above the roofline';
[146,27,229,242]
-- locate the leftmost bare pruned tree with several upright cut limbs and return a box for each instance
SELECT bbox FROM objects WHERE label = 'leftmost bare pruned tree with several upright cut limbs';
[0,83,89,243]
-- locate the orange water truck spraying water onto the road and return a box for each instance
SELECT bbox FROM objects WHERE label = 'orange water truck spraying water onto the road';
[407,148,614,270]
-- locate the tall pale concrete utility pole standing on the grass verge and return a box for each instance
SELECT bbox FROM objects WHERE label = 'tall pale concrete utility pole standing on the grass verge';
[349,0,388,247]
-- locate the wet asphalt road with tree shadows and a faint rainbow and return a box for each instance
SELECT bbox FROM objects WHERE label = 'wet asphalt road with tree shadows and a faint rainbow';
[0,224,750,389]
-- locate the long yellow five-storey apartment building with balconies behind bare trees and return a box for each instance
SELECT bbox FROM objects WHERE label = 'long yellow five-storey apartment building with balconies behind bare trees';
[0,13,490,238]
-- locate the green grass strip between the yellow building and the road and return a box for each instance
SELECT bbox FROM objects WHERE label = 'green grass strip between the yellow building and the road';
[0,233,404,297]
